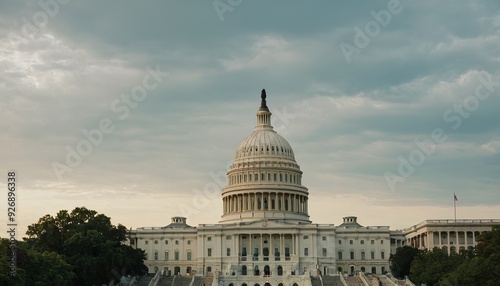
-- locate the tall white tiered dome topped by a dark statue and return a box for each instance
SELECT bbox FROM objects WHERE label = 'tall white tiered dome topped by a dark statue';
[220,90,311,223]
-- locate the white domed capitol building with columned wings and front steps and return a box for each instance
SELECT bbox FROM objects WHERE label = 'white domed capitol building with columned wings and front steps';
[128,90,500,286]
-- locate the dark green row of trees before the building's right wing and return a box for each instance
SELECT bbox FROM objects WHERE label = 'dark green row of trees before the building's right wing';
[390,226,500,286]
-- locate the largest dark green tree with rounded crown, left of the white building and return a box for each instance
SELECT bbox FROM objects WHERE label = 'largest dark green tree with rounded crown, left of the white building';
[26,207,147,285]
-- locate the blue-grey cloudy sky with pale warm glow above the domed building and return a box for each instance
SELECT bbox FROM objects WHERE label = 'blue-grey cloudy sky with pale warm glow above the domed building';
[0,0,500,236]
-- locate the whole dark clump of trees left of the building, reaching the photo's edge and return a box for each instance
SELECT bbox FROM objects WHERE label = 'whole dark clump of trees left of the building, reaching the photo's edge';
[0,207,147,286]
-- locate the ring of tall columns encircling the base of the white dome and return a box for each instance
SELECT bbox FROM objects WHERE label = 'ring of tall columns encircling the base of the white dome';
[222,192,308,214]
